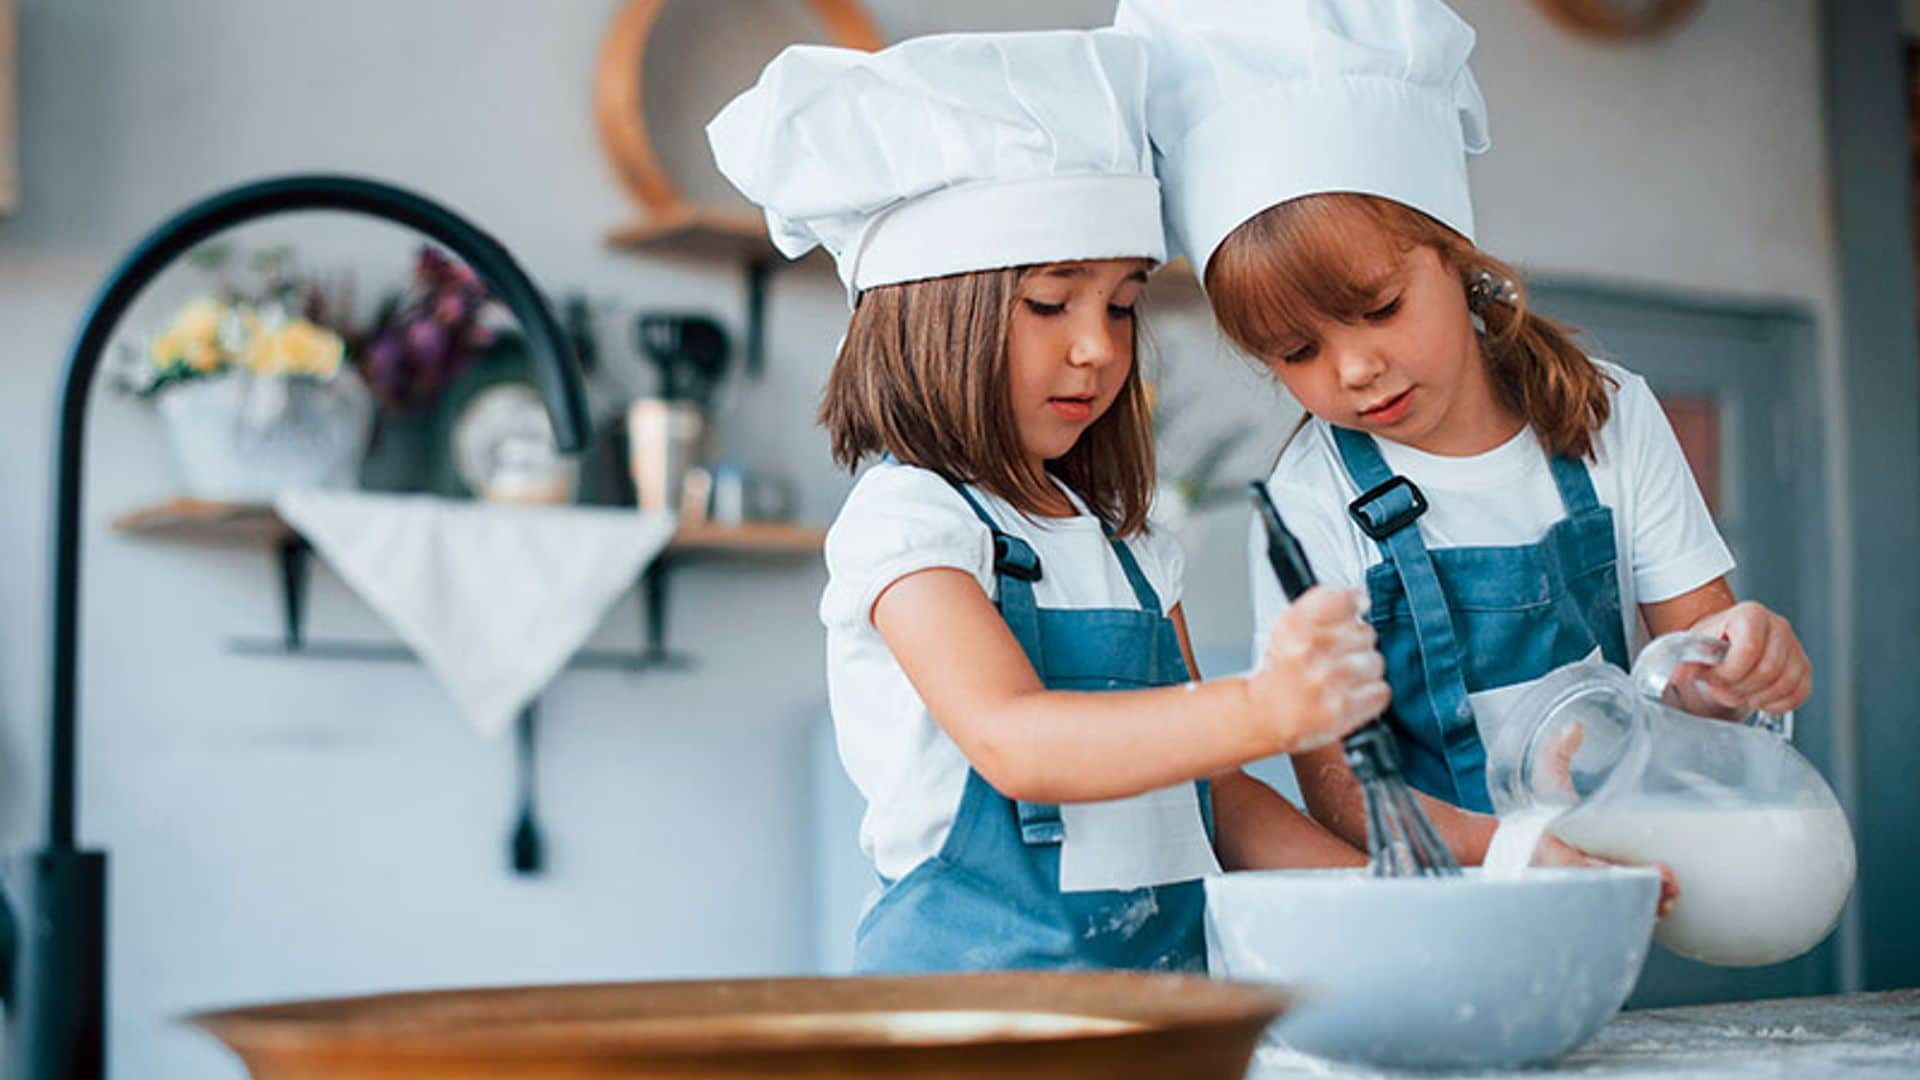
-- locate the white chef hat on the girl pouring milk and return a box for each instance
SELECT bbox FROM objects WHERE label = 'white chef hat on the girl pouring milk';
[1114,0,1488,279]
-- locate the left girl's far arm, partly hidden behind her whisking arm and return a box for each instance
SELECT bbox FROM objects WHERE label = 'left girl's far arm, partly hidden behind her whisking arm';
[1169,605,1367,871]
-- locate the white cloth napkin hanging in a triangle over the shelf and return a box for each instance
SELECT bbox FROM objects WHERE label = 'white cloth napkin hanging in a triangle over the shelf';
[275,490,674,736]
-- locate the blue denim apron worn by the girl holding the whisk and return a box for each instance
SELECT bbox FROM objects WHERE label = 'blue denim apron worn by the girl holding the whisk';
[854,484,1213,972]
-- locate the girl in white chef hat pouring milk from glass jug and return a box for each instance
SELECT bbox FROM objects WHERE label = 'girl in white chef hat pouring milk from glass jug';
[1116,0,1809,863]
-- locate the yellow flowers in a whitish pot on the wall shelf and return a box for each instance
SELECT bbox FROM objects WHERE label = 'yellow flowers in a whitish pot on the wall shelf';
[129,248,372,502]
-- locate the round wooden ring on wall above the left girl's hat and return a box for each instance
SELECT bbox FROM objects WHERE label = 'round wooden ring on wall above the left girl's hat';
[593,0,885,219]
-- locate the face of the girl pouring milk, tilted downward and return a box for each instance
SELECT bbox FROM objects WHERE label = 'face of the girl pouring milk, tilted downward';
[1265,244,1521,455]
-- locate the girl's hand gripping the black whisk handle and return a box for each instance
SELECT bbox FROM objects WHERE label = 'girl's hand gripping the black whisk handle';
[1246,586,1392,753]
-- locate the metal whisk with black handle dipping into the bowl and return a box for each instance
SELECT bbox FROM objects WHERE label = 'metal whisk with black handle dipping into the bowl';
[1252,480,1459,878]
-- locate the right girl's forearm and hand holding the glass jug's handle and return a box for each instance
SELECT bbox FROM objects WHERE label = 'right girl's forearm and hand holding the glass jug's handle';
[1640,577,1812,717]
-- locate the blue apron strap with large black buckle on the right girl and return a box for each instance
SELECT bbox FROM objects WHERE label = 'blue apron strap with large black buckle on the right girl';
[1332,427,1486,805]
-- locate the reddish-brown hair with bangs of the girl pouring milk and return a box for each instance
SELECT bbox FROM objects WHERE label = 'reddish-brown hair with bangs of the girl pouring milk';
[1206,192,1613,457]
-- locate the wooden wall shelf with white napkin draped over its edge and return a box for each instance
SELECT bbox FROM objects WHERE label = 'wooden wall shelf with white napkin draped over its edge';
[113,498,826,555]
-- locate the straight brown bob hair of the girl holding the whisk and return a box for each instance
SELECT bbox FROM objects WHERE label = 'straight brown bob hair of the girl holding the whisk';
[820,267,1154,536]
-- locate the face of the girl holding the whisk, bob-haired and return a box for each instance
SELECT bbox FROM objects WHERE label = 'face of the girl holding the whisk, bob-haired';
[1006,259,1152,471]
